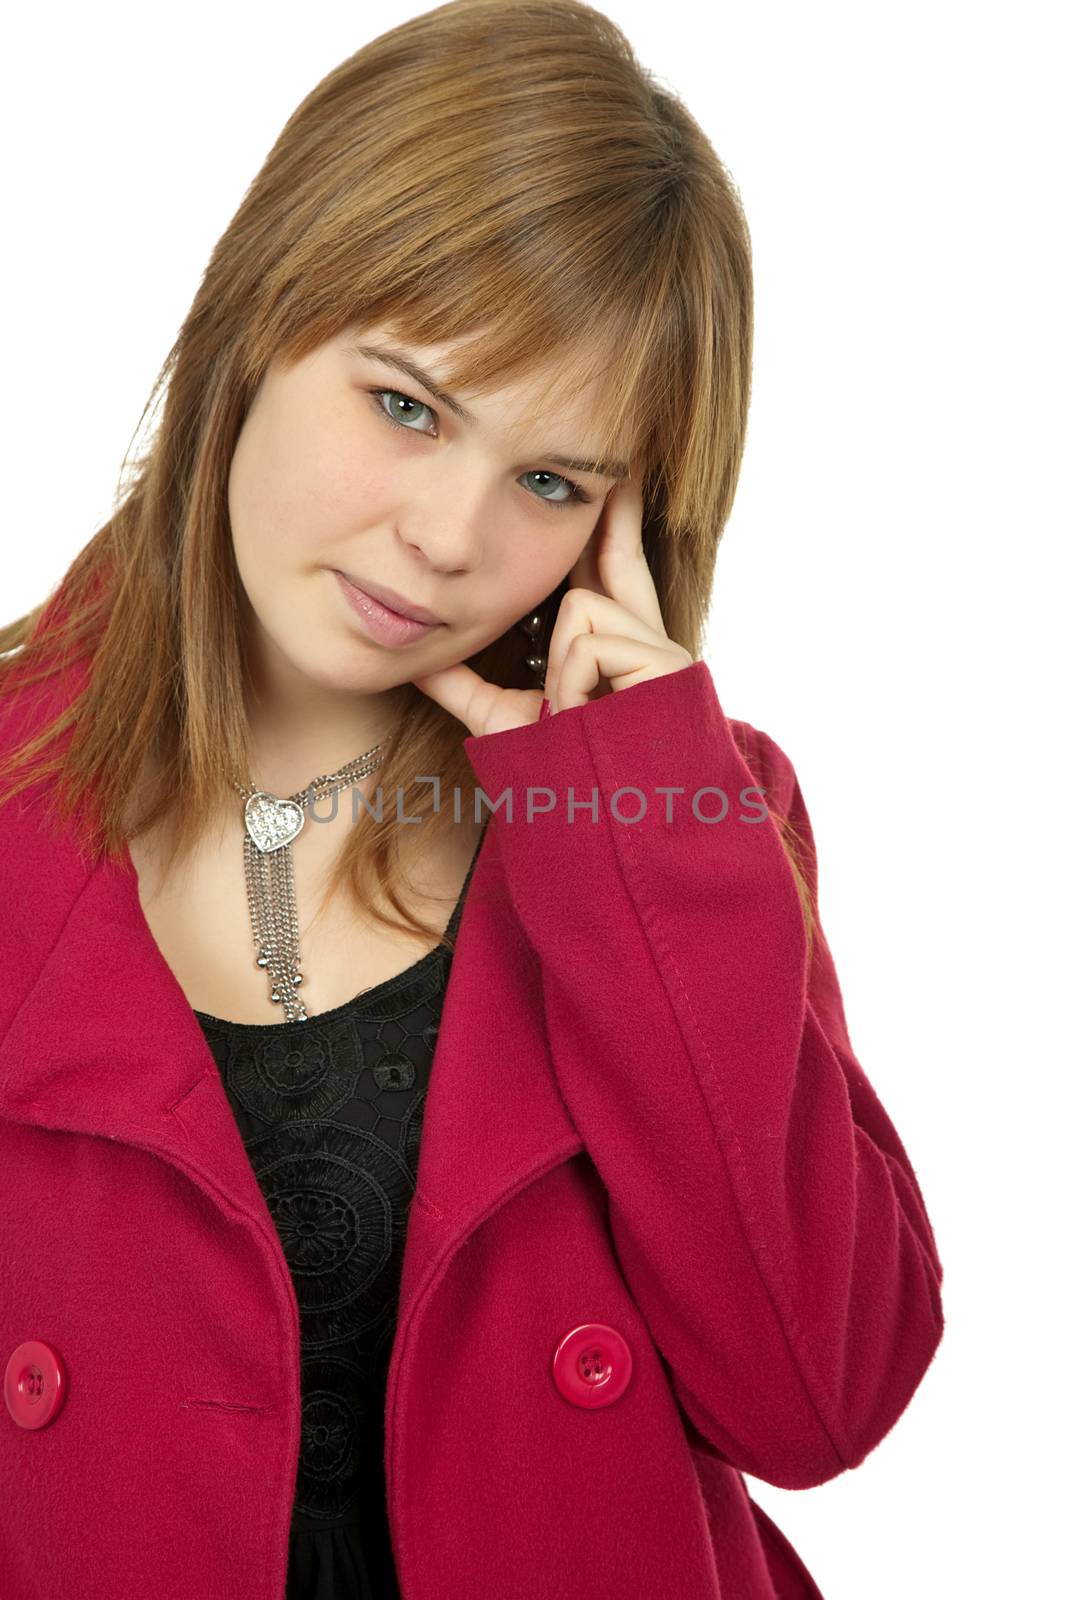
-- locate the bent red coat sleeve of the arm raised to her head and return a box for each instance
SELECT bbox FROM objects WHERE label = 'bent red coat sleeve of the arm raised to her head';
[464,661,944,1488]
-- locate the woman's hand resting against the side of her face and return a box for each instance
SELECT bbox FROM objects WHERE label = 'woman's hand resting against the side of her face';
[411,478,693,736]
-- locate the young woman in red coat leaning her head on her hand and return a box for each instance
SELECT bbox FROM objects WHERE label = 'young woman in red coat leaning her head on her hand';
[0,0,942,1600]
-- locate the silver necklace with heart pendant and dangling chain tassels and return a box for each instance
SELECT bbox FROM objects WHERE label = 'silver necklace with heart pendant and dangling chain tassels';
[230,744,386,1022]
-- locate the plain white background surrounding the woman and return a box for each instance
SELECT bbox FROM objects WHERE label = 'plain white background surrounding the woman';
[0,0,1067,1600]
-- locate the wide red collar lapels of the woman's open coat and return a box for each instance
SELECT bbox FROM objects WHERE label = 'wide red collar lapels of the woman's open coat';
[0,700,582,1299]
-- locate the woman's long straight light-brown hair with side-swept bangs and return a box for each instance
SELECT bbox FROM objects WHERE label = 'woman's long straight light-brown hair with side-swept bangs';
[0,0,813,944]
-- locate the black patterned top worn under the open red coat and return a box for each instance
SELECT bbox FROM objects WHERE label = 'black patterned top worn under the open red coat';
[195,829,485,1600]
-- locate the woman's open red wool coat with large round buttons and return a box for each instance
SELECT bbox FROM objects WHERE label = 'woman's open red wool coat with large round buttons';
[0,661,942,1600]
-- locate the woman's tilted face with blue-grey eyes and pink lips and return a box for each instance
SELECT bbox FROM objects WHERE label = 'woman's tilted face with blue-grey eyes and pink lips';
[229,326,627,693]
